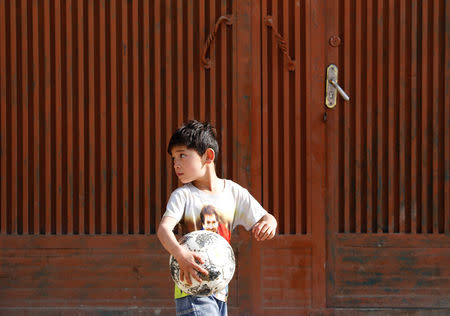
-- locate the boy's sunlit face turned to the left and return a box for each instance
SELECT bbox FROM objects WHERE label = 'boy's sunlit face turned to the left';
[172,146,205,183]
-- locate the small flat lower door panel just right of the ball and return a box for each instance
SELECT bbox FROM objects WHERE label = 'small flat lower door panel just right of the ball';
[251,235,317,315]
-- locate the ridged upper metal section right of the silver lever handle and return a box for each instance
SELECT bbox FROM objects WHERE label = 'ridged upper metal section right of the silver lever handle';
[337,0,449,234]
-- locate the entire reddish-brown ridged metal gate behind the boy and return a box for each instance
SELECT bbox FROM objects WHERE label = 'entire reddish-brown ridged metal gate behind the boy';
[0,0,450,315]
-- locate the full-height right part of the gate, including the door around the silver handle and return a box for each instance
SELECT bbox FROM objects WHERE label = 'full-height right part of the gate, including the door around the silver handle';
[253,0,450,315]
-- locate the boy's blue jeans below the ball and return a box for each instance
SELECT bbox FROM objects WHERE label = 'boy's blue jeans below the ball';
[175,295,228,316]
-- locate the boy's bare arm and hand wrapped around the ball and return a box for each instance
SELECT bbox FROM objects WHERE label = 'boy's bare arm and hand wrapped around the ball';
[157,216,208,284]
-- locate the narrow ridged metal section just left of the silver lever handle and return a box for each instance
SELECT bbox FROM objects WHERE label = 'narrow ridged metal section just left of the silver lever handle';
[261,0,310,234]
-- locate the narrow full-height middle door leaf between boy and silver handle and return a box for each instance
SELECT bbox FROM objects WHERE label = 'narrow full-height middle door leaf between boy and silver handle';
[252,0,325,315]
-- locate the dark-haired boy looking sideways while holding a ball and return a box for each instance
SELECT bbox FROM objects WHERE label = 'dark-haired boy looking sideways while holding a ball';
[157,121,277,316]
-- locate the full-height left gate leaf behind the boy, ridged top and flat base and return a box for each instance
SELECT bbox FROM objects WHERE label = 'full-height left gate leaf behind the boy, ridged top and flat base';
[0,0,243,314]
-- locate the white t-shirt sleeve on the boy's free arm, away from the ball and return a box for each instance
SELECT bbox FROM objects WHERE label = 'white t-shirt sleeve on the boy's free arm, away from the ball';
[233,185,267,230]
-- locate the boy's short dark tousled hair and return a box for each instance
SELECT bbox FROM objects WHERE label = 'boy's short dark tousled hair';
[167,120,219,160]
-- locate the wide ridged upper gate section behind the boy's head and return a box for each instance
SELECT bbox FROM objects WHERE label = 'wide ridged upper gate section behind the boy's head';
[0,0,235,235]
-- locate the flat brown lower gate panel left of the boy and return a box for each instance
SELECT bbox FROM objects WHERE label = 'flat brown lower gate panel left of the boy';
[0,236,174,314]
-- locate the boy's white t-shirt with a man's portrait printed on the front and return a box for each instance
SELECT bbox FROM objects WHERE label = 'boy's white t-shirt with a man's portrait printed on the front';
[164,180,267,301]
